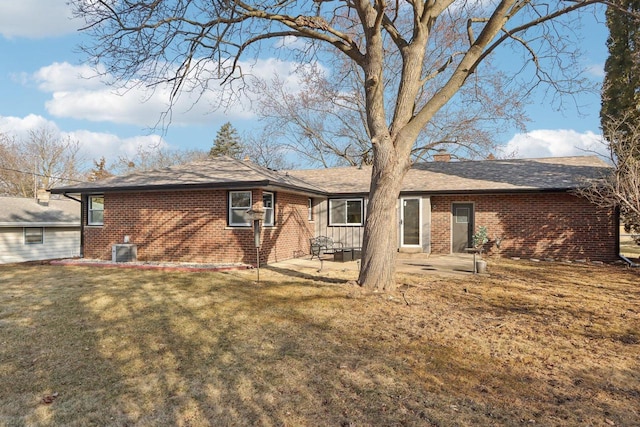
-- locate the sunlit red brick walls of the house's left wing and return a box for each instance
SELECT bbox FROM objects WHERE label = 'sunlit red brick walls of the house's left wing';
[84,190,311,264]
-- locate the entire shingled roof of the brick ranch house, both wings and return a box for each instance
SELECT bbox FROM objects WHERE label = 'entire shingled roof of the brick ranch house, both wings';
[52,156,610,195]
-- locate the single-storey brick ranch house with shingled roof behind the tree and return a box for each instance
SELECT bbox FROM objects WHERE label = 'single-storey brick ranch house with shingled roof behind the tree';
[52,155,619,264]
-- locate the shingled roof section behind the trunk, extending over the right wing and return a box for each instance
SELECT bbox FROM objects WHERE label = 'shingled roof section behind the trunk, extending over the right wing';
[289,156,610,194]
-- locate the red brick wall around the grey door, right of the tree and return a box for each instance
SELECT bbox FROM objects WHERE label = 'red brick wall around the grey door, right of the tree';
[431,193,618,261]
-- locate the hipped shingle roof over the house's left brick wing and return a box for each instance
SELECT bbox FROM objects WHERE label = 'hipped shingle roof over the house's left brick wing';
[52,156,324,194]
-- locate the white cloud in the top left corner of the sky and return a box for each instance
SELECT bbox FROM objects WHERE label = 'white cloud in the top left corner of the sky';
[0,0,80,39]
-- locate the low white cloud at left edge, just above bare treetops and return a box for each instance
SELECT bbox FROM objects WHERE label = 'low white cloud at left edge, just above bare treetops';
[0,114,169,166]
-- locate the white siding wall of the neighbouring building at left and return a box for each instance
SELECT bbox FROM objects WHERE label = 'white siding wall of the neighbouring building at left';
[0,227,80,264]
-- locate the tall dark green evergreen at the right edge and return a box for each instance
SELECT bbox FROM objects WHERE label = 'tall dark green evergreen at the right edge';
[600,0,640,147]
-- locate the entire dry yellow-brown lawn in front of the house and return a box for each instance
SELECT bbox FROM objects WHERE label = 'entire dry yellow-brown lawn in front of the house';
[0,261,640,426]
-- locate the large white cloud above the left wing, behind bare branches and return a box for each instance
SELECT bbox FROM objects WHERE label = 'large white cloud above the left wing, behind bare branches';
[32,59,312,127]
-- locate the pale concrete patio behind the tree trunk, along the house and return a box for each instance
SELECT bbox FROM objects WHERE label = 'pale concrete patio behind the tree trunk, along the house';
[270,253,473,276]
